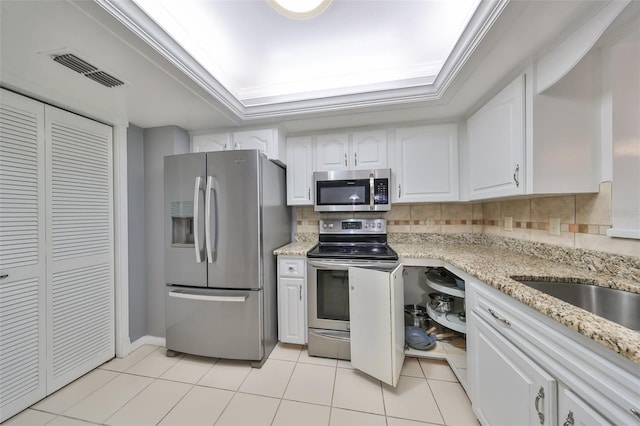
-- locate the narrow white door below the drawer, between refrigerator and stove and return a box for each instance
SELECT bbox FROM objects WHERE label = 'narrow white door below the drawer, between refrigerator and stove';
[278,277,306,345]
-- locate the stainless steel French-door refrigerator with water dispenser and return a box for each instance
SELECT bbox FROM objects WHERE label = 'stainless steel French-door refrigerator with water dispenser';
[164,150,291,367]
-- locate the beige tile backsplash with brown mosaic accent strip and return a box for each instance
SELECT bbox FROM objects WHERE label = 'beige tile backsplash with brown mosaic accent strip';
[297,182,640,257]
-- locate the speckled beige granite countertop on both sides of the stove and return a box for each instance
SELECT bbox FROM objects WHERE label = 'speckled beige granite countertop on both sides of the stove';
[274,240,640,364]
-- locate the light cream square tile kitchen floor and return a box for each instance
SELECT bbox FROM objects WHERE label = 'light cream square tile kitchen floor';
[5,344,478,426]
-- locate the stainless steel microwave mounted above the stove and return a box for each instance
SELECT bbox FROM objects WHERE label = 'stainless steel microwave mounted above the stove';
[313,169,391,212]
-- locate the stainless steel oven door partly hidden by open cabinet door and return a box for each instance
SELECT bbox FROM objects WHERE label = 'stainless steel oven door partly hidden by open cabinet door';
[307,259,398,331]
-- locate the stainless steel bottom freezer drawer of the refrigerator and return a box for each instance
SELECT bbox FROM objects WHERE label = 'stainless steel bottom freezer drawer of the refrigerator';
[165,286,264,361]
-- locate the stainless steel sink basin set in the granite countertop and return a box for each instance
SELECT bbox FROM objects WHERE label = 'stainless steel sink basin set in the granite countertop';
[517,280,640,331]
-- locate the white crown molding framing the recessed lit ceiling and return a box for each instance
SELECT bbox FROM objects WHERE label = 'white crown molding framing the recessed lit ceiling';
[94,0,510,121]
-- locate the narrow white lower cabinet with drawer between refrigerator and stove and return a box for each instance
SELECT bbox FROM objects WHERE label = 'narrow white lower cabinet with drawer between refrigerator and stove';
[278,256,307,345]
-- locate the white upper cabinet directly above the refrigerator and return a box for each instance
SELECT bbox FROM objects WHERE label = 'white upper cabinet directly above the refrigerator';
[191,129,286,163]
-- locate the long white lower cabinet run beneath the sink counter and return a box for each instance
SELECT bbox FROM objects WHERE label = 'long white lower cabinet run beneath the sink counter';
[466,280,640,426]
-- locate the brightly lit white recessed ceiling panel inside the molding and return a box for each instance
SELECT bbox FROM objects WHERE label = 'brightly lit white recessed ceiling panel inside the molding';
[133,0,485,106]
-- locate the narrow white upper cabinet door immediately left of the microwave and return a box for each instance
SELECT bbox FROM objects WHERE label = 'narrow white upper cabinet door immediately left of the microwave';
[287,136,314,206]
